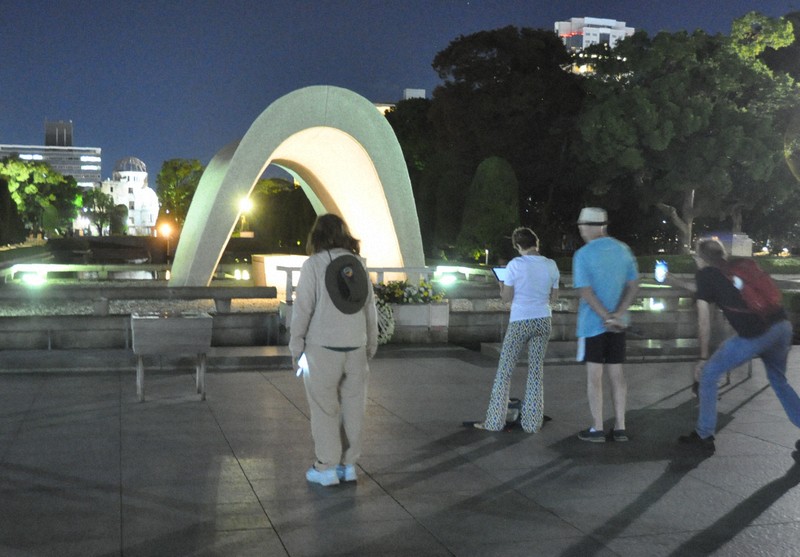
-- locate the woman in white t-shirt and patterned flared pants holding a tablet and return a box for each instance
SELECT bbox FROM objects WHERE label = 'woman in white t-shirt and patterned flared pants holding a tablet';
[474,227,560,433]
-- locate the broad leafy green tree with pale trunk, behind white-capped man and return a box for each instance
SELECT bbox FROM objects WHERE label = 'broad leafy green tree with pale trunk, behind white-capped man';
[579,27,800,251]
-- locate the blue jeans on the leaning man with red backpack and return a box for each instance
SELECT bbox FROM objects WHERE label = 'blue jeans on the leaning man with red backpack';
[696,321,800,439]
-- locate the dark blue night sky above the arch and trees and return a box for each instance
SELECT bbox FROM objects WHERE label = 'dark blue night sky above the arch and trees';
[0,0,800,178]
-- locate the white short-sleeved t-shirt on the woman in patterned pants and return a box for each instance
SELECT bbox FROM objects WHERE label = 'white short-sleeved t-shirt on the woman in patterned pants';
[503,255,560,321]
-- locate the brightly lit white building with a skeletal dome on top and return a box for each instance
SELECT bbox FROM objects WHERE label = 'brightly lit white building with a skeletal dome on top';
[100,157,158,236]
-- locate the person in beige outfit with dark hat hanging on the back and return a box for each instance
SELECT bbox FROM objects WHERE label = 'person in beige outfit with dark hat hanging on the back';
[289,214,378,486]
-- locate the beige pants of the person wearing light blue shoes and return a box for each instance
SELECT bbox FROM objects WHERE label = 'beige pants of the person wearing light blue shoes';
[304,345,369,470]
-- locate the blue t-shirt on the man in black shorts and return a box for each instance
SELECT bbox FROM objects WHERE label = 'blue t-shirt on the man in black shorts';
[572,236,639,337]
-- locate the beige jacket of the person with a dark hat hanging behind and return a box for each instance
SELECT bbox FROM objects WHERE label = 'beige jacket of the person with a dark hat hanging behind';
[289,248,378,362]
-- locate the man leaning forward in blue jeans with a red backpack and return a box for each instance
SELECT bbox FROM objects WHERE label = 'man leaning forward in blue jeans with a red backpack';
[673,238,800,459]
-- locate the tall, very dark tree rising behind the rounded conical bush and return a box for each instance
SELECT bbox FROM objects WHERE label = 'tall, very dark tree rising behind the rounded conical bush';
[430,26,583,248]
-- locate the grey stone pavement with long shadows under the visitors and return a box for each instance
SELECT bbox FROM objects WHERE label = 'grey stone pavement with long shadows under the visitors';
[0,346,800,557]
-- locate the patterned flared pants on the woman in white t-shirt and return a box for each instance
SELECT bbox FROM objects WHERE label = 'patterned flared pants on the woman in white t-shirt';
[484,317,551,433]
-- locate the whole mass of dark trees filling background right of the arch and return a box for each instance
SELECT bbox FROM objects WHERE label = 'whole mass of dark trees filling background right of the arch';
[387,13,800,257]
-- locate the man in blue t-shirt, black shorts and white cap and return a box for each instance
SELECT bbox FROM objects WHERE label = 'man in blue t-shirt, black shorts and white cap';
[572,207,639,443]
